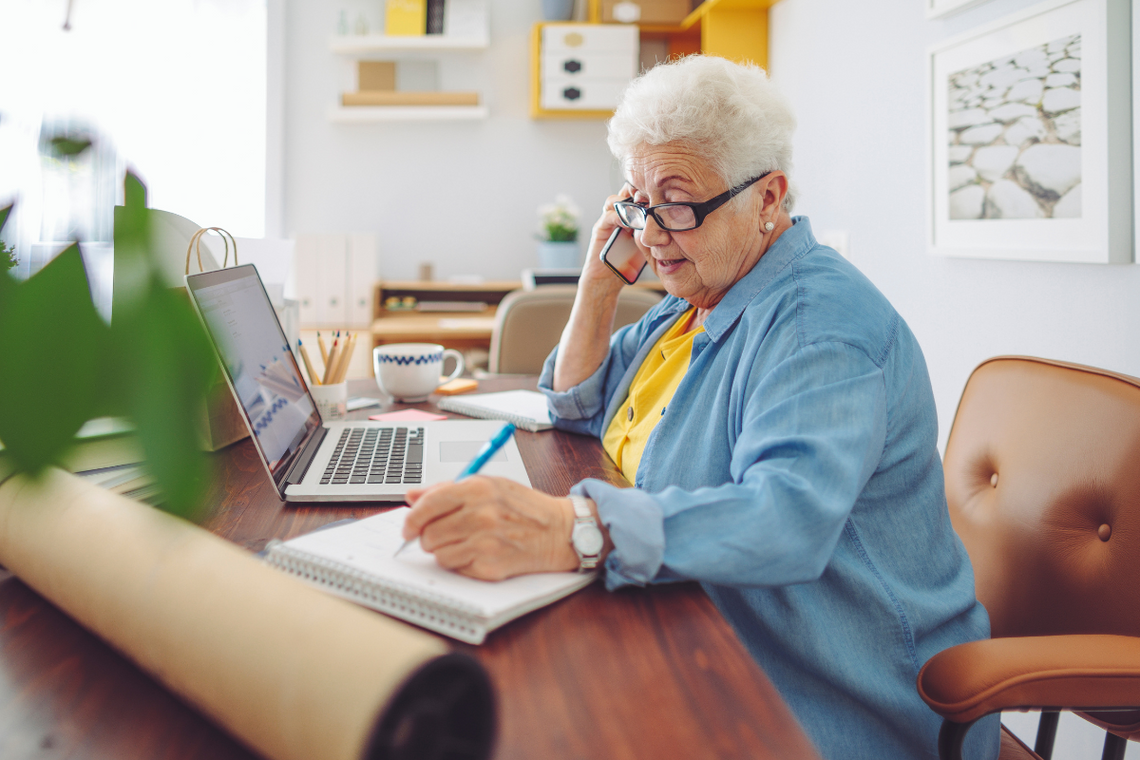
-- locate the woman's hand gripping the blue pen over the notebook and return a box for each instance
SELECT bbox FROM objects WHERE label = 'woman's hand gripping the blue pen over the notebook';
[404,475,578,580]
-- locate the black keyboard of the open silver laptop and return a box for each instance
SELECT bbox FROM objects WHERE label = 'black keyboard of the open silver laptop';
[320,427,424,485]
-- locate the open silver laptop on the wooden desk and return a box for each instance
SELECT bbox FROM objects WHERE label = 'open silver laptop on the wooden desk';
[186,264,530,502]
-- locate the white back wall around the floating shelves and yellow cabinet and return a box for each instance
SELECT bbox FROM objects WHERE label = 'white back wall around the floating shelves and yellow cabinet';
[283,0,620,279]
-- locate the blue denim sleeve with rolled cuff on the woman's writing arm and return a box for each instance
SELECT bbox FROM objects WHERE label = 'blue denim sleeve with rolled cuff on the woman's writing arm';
[577,344,887,588]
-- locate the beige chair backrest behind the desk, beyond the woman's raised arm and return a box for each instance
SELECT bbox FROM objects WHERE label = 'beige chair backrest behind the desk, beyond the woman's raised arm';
[488,285,661,375]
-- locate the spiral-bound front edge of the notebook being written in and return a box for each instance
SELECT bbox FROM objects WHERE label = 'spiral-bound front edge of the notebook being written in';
[266,540,486,644]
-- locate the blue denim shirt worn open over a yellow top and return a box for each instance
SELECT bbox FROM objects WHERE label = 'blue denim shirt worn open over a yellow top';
[539,216,998,760]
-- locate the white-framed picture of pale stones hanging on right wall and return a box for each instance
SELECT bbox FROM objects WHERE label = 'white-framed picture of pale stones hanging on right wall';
[927,0,1133,263]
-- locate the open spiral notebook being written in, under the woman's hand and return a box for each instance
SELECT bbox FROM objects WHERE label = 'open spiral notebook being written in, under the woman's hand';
[264,507,595,644]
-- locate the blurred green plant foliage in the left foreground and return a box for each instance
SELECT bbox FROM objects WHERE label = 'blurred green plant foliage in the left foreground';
[0,138,217,517]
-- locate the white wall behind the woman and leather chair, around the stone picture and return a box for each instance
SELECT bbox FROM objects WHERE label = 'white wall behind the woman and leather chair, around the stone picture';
[771,0,1140,759]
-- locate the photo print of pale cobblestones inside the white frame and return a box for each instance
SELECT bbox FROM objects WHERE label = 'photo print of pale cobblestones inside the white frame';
[946,34,1081,220]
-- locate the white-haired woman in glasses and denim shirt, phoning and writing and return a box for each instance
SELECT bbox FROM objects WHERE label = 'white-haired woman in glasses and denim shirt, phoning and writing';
[406,56,998,760]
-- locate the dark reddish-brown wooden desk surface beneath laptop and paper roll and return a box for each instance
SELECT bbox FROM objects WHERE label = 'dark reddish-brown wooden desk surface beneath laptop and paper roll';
[0,378,817,760]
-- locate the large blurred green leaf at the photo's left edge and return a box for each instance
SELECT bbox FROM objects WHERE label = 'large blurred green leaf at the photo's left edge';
[0,244,107,473]
